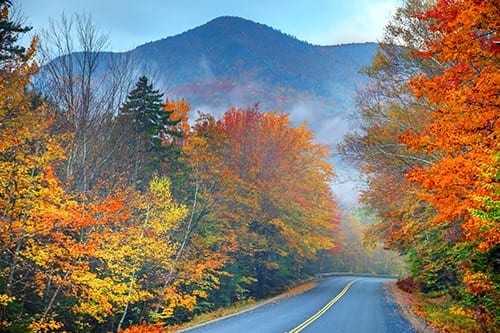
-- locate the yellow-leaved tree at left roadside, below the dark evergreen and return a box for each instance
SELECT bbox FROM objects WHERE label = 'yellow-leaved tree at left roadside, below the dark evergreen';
[69,177,190,331]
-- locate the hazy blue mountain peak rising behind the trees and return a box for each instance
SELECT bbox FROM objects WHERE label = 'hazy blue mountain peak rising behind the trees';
[131,16,376,112]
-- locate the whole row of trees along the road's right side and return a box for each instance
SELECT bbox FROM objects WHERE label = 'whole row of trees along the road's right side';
[340,0,500,332]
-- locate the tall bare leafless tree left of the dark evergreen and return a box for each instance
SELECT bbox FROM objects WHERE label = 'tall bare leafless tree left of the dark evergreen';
[35,14,135,196]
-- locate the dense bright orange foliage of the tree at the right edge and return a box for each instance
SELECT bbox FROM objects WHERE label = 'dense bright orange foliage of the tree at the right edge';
[402,1,500,251]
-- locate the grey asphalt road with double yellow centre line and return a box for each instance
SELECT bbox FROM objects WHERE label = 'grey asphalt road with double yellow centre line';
[183,277,415,333]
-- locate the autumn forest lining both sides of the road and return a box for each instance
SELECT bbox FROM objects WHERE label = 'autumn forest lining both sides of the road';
[0,0,500,333]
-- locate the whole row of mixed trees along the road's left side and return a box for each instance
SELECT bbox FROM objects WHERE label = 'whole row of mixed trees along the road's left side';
[0,0,338,332]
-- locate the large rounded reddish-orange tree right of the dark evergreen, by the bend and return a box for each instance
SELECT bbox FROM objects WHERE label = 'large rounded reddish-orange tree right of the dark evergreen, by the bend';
[185,108,336,300]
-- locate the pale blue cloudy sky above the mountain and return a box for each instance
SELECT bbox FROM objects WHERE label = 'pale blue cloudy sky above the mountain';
[19,0,400,52]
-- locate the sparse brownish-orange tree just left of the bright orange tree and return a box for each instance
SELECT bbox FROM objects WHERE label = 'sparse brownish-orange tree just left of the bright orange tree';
[339,1,446,287]
